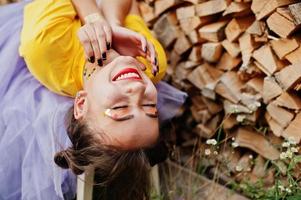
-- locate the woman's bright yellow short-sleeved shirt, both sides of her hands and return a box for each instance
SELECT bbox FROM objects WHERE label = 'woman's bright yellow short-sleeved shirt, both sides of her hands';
[19,0,167,96]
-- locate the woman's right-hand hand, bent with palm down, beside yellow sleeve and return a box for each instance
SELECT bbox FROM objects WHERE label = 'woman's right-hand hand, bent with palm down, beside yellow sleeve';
[112,26,159,75]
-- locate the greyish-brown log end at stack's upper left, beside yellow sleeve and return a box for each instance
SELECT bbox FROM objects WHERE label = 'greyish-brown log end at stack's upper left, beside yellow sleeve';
[153,13,181,48]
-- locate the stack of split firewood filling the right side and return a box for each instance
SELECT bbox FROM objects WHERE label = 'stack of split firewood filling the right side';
[139,0,301,187]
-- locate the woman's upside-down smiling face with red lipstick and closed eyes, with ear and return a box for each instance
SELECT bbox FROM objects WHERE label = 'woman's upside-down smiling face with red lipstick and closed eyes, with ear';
[75,56,159,149]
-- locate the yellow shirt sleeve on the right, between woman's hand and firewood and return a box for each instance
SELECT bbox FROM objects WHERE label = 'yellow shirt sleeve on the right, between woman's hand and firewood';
[124,15,167,83]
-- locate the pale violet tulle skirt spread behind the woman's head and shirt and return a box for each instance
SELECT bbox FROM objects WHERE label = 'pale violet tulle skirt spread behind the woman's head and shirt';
[0,1,187,200]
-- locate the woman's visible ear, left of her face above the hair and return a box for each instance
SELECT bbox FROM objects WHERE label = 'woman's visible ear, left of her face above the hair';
[73,90,88,120]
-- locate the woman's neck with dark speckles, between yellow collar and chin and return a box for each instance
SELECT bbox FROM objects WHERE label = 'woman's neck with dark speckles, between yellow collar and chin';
[83,49,120,85]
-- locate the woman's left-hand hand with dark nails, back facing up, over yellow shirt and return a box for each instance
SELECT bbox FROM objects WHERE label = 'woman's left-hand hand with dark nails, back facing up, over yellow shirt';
[78,13,112,66]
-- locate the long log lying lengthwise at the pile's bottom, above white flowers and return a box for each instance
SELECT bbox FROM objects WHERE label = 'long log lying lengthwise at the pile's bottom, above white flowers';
[235,128,280,160]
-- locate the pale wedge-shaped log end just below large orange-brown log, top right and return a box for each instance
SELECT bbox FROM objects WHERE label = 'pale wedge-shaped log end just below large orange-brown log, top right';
[271,39,300,60]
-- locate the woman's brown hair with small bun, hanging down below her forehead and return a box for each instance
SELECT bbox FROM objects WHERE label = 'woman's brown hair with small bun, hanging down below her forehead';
[54,107,150,200]
